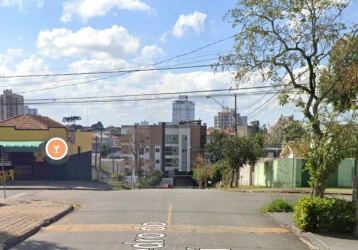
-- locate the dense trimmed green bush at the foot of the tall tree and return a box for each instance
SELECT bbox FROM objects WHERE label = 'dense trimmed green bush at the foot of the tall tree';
[293,196,358,233]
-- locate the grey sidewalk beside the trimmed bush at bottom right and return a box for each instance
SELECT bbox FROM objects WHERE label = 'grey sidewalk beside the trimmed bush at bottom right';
[268,213,358,250]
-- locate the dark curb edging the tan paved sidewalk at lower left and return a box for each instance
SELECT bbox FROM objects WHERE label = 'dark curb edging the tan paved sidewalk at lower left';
[0,205,75,250]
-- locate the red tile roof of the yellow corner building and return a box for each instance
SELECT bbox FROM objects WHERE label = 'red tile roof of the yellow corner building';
[0,114,66,129]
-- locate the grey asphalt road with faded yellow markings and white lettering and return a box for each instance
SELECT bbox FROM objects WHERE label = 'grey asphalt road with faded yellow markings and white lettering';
[7,189,309,250]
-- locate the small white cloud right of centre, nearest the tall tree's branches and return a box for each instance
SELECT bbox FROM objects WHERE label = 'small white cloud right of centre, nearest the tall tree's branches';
[173,11,206,37]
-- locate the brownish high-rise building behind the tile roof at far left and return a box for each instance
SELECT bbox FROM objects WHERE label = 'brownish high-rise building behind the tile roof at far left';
[0,89,24,121]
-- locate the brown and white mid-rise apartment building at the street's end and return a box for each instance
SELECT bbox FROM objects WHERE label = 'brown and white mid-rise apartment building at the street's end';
[121,121,206,185]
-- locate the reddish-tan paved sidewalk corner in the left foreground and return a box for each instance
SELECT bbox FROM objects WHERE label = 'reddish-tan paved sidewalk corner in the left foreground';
[0,199,74,250]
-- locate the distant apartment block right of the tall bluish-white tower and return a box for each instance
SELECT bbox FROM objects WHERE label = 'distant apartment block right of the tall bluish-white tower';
[214,109,247,129]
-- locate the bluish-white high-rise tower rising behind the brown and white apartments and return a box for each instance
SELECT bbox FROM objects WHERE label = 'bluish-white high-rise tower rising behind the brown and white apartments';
[172,95,195,122]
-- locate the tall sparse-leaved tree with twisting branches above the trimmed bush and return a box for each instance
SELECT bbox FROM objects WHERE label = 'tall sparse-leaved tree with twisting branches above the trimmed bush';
[215,0,356,197]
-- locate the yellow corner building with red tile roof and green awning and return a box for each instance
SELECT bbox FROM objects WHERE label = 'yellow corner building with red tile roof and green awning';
[0,114,92,180]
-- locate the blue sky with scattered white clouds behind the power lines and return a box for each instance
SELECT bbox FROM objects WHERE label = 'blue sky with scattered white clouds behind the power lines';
[0,0,358,127]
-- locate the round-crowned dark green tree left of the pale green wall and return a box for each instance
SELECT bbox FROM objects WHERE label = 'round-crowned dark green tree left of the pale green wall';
[224,134,264,187]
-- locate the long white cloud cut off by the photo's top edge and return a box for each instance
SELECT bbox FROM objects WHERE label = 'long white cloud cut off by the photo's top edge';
[61,0,155,22]
